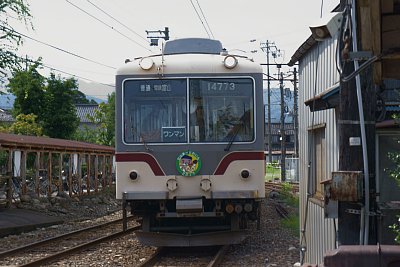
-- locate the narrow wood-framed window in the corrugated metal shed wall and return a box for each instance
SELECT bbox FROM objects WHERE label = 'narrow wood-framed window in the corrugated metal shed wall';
[309,127,328,200]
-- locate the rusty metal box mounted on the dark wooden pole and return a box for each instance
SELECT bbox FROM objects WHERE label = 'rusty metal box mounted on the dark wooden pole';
[323,171,363,201]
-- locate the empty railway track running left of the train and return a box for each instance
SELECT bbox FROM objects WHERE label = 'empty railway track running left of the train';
[0,219,139,266]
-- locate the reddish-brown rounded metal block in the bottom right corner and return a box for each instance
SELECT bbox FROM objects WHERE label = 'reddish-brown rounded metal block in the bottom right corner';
[323,245,400,267]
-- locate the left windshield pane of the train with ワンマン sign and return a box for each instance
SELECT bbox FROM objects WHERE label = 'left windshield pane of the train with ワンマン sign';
[123,79,187,143]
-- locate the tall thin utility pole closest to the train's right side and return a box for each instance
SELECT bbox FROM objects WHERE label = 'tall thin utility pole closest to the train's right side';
[260,40,279,164]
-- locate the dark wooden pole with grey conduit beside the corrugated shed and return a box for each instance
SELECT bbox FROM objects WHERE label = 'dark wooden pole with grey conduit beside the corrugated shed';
[337,1,377,245]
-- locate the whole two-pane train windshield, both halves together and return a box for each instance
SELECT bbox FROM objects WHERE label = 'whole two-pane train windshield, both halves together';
[123,78,254,145]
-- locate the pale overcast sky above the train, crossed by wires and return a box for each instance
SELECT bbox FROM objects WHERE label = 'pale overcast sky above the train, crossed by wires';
[10,0,340,99]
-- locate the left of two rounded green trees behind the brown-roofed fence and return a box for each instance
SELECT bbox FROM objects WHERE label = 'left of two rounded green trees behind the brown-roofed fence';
[8,62,45,120]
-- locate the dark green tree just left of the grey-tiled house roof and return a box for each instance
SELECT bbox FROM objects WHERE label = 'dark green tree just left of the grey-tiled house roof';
[43,73,79,139]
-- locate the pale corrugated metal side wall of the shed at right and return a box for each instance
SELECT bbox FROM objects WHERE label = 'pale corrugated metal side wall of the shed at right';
[299,39,339,264]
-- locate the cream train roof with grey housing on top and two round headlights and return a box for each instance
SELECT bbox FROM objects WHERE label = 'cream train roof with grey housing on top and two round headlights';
[117,38,262,75]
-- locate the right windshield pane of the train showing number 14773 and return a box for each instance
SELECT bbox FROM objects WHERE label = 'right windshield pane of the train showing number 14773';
[189,78,254,143]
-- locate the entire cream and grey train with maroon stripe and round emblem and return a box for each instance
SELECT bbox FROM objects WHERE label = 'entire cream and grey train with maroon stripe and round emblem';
[116,38,265,246]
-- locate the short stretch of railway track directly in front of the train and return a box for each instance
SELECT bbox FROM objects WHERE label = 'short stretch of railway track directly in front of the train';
[139,245,229,267]
